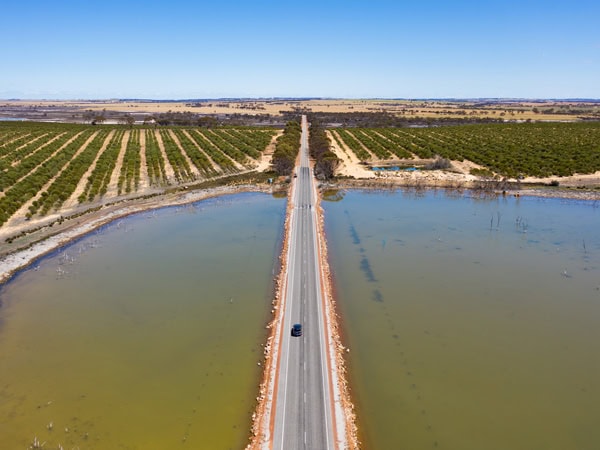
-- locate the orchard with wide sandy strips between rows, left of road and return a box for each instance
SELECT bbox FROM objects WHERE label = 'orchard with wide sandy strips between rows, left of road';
[0,122,278,225]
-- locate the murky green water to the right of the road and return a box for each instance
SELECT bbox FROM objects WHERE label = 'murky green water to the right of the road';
[324,192,600,450]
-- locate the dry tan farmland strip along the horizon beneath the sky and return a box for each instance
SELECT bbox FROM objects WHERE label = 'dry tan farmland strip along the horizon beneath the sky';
[0,99,600,121]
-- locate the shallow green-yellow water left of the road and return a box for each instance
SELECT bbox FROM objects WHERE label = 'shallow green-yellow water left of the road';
[0,194,285,450]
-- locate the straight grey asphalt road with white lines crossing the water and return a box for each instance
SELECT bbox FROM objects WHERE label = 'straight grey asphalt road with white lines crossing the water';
[272,116,335,450]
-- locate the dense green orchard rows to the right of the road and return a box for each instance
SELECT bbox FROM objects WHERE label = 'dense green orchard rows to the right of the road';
[332,123,600,178]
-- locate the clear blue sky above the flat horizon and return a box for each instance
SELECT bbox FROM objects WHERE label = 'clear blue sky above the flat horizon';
[0,0,600,99]
